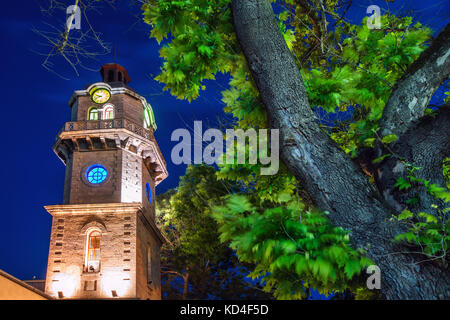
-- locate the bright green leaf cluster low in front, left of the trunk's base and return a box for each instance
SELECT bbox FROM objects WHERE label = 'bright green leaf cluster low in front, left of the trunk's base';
[214,194,371,299]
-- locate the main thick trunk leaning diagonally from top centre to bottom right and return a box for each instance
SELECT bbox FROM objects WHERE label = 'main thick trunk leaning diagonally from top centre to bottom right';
[231,0,450,299]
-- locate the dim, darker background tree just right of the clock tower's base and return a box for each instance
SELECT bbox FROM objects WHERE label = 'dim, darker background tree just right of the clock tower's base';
[157,166,270,299]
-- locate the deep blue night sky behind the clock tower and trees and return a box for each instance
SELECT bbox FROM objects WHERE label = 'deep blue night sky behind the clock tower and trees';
[0,0,450,279]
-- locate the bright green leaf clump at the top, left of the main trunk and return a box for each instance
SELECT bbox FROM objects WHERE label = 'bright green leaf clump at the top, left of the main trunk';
[143,0,233,100]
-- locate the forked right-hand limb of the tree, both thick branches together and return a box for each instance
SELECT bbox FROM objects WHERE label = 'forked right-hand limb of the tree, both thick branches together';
[375,24,450,213]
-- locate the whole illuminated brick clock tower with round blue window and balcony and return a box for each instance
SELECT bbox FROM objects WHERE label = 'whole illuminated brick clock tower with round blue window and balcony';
[45,63,168,299]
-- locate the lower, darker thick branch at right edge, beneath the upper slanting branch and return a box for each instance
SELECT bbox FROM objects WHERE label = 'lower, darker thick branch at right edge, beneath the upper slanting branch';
[375,105,450,213]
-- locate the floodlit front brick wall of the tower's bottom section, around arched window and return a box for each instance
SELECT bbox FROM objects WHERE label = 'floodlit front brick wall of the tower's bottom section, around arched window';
[46,213,141,299]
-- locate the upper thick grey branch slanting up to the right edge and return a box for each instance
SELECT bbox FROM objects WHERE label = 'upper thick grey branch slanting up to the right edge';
[380,24,450,136]
